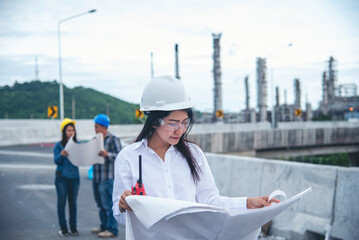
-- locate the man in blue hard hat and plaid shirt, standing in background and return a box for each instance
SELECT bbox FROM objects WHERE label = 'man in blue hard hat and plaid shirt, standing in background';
[91,114,122,238]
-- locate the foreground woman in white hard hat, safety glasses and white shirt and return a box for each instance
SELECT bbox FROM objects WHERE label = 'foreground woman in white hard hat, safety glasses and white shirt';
[113,76,278,230]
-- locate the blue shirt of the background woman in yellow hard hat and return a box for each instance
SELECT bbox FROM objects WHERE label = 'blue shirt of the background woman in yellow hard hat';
[54,142,80,179]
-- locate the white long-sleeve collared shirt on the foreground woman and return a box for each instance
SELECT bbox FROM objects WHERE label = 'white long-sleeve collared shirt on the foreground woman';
[112,139,247,224]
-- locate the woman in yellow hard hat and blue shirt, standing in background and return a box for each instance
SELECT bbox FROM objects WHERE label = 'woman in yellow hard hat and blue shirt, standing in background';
[54,118,80,237]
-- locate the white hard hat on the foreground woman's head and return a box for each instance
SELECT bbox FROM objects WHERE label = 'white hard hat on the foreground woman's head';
[140,75,194,112]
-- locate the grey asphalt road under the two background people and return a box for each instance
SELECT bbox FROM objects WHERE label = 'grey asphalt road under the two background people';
[0,144,125,240]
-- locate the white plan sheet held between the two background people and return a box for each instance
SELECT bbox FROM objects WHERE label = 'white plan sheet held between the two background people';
[65,133,105,167]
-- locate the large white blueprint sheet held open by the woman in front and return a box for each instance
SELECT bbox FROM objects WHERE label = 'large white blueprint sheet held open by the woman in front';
[126,188,312,240]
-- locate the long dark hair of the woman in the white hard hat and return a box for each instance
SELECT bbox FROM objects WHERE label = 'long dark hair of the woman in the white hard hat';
[135,108,200,182]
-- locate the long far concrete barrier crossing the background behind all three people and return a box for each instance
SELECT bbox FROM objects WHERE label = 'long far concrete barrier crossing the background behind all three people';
[0,119,359,148]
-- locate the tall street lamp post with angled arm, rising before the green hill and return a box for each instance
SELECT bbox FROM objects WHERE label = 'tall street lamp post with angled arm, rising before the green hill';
[57,9,96,121]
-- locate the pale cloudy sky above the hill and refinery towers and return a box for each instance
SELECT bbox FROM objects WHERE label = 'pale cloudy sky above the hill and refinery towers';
[0,0,359,111]
